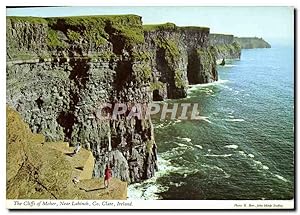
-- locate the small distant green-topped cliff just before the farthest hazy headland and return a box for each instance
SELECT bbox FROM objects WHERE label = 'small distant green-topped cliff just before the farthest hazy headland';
[209,34,241,63]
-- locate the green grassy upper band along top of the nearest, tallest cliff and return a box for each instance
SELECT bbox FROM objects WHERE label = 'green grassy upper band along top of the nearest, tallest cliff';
[7,14,144,51]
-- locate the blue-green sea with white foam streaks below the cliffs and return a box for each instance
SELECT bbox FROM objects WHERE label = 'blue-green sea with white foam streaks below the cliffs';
[129,47,294,199]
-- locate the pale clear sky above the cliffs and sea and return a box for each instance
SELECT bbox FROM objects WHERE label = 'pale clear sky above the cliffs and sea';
[7,6,294,44]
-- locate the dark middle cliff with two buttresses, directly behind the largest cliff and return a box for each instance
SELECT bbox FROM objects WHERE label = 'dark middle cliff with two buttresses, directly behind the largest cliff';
[144,23,218,100]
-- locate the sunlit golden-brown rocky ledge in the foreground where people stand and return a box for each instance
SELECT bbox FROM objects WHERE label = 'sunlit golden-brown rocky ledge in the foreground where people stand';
[6,107,127,199]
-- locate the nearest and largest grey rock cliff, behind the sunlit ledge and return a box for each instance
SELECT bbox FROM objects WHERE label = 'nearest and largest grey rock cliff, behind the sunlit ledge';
[7,15,156,182]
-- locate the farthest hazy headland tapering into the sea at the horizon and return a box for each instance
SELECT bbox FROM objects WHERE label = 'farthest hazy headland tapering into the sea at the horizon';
[235,37,271,49]
